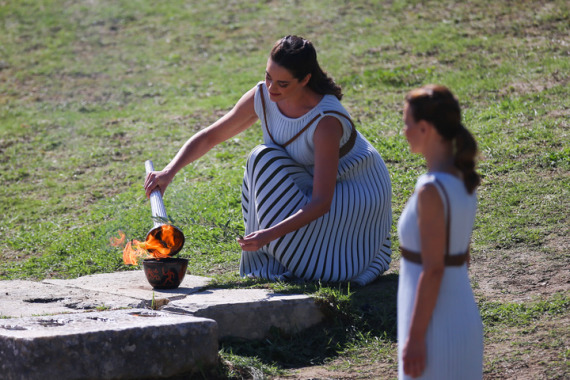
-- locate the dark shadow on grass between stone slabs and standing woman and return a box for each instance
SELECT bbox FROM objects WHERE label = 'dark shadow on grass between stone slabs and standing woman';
[215,274,398,369]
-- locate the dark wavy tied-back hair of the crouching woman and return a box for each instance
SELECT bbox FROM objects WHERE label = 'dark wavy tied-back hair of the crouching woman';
[271,36,342,100]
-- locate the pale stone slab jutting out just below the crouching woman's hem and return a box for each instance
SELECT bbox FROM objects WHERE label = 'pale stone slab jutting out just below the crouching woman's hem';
[162,289,324,339]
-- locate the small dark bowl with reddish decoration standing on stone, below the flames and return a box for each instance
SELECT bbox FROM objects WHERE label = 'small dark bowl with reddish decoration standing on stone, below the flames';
[143,257,188,289]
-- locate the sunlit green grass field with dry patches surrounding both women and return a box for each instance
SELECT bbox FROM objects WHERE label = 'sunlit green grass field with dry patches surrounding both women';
[0,0,570,379]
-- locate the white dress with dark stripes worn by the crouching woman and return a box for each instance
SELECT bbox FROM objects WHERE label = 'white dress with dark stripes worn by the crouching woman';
[240,83,392,285]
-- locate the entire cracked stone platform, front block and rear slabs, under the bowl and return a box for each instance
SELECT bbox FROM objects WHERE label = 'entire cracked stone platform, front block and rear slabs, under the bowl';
[0,270,324,380]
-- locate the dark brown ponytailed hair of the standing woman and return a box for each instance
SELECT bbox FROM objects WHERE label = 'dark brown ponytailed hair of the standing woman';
[406,85,481,193]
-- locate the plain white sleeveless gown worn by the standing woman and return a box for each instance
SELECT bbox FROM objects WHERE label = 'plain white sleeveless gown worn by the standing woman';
[398,173,483,380]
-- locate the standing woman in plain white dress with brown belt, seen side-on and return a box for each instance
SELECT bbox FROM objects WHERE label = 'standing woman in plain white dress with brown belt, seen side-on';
[398,85,483,380]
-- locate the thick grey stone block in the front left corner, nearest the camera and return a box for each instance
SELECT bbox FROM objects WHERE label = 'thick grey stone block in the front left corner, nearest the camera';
[0,309,218,380]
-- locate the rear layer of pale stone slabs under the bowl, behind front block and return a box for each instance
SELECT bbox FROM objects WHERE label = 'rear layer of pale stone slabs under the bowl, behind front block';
[0,269,323,339]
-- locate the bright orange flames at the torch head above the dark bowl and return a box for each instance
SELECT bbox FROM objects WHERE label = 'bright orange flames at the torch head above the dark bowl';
[111,224,184,265]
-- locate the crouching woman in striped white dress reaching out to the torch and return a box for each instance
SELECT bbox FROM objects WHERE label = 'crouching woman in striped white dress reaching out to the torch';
[145,36,392,285]
